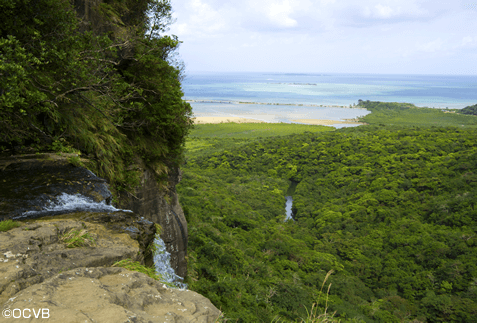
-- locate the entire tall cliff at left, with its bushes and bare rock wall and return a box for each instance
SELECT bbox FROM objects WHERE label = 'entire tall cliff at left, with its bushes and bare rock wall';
[0,0,190,277]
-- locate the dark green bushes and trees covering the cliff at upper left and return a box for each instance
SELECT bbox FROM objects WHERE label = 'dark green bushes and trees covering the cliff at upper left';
[0,0,191,195]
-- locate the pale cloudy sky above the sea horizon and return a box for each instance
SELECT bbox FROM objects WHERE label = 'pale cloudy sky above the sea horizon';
[168,0,477,75]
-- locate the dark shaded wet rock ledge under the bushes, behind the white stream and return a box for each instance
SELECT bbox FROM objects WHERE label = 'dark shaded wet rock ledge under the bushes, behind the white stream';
[0,154,111,221]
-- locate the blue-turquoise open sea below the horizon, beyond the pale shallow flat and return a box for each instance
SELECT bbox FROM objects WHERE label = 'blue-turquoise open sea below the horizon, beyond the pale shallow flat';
[183,73,477,108]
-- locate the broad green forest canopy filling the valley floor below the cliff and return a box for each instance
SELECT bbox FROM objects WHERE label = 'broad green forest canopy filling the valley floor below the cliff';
[178,111,477,323]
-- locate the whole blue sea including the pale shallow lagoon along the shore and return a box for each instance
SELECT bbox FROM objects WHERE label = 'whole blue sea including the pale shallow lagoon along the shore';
[182,72,477,127]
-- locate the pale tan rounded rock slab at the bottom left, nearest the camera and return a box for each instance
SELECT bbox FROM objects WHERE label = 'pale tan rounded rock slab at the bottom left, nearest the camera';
[0,267,221,323]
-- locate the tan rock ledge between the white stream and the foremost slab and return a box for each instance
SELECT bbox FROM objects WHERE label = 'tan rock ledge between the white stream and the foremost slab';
[0,212,155,304]
